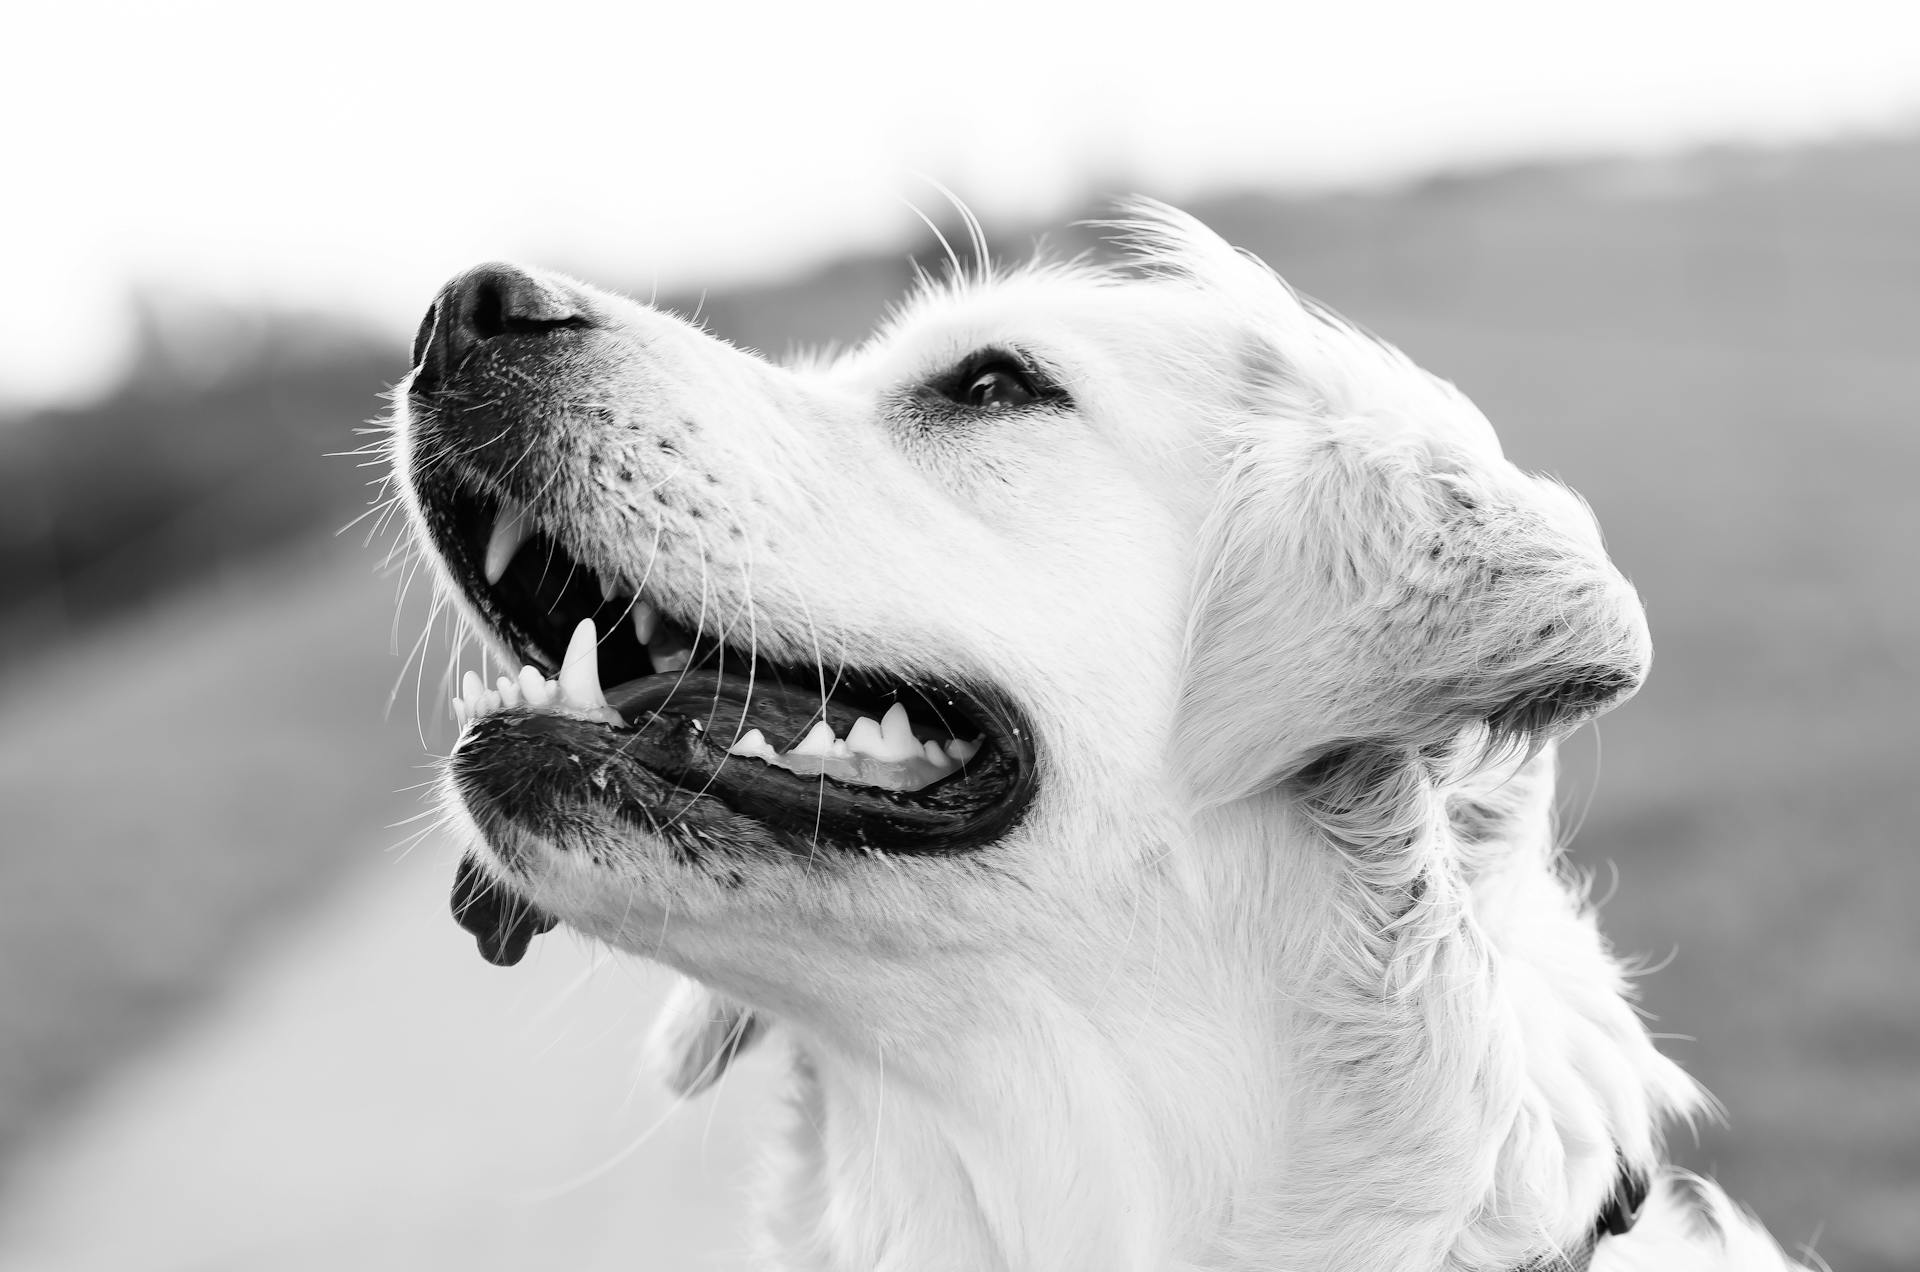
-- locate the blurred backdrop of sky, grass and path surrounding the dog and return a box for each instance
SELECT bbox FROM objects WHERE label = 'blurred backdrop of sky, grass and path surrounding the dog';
[0,0,1920,1272]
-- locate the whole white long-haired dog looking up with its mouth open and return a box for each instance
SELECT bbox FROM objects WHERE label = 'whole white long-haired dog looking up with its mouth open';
[392,202,1795,1272]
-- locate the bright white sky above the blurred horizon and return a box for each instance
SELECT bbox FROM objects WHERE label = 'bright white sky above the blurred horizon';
[0,0,1920,404]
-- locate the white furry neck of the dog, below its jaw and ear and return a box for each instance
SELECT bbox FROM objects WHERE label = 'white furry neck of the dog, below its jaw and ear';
[748,757,1693,1272]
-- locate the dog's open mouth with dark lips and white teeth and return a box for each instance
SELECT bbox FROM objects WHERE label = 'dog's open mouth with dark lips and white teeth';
[422,488,1035,853]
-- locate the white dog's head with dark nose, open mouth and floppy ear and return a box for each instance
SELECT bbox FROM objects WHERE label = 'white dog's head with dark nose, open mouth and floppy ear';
[396,206,1649,1051]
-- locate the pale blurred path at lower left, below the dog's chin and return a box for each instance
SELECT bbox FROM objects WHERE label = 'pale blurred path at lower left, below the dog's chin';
[0,842,778,1272]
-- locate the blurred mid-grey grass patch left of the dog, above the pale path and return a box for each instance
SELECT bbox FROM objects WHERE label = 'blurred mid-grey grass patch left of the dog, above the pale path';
[0,536,444,1152]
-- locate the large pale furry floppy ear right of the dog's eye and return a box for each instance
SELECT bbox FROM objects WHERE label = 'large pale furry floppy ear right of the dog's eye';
[1175,343,1651,807]
